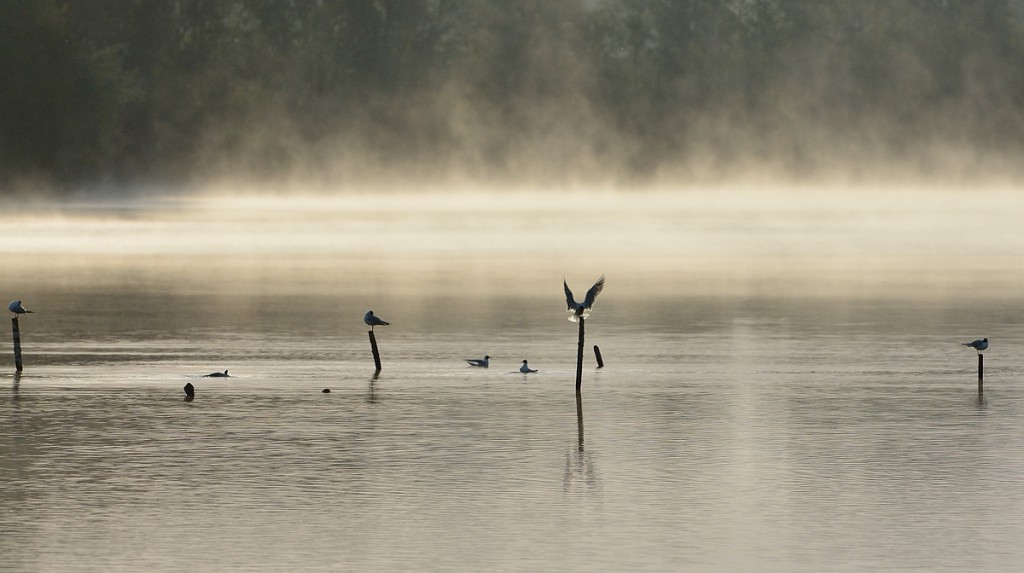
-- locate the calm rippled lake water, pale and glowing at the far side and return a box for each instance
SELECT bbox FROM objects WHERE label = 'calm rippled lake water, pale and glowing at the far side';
[0,190,1024,572]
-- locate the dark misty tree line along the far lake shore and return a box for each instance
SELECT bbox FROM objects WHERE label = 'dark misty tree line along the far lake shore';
[0,0,1024,192]
